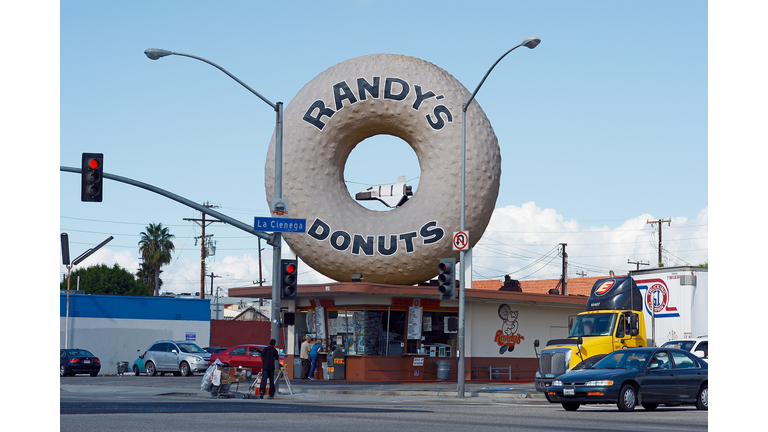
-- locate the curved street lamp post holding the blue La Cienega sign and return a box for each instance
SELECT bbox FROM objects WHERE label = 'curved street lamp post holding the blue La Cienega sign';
[144,48,283,341]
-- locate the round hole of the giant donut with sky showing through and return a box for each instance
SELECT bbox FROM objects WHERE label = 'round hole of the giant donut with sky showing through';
[344,134,421,211]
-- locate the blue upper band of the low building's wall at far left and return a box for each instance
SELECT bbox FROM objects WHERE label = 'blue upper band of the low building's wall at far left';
[59,293,211,321]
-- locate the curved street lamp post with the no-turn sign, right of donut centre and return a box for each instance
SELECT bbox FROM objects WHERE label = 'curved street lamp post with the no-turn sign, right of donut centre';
[457,36,541,398]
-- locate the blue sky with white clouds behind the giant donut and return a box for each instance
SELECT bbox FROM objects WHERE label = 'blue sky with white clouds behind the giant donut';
[49,1,709,292]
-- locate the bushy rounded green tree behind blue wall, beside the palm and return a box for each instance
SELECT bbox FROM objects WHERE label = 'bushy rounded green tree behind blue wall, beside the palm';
[60,264,151,296]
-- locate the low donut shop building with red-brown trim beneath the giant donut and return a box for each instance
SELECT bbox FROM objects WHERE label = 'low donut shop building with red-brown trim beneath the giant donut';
[229,278,597,381]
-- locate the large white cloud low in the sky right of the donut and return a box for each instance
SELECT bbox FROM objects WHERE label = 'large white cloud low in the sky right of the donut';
[473,202,708,280]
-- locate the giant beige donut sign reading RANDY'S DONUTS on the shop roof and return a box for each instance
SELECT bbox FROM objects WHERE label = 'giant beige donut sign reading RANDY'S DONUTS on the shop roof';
[265,54,501,284]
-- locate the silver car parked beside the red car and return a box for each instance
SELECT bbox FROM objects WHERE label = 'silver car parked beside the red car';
[143,341,211,376]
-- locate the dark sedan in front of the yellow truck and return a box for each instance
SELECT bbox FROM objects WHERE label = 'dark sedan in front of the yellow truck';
[548,347,709,411]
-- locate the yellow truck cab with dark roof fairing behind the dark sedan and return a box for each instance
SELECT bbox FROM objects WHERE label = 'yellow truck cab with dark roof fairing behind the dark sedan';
[534,277,647,394]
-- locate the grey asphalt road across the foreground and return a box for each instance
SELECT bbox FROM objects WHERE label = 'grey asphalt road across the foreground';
[59,377,708,432]
